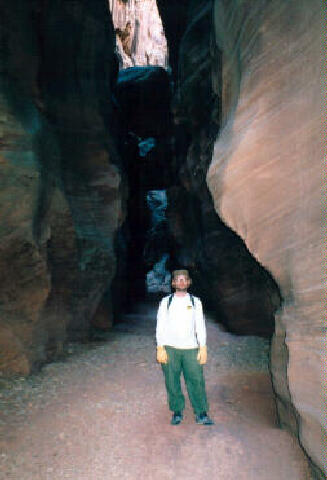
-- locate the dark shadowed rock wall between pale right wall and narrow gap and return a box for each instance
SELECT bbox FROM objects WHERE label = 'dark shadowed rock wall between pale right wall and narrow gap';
[159,0,280,337]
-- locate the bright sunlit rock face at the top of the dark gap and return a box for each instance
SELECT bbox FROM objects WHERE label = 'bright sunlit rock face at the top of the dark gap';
[109,0,168,68]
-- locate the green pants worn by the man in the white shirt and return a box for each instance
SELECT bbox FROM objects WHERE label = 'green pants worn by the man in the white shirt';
[161,346,208,415]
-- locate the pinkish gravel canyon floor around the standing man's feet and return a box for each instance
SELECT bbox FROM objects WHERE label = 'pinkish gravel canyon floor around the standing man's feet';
[0,305,310,480]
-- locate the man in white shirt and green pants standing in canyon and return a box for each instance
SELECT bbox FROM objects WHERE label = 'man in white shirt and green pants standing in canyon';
[156,270,214,425]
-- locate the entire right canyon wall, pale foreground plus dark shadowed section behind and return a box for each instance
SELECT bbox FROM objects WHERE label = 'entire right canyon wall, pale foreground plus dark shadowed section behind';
[158,0,324,478]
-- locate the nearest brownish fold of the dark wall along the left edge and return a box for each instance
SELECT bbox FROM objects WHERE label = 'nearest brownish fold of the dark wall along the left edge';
[0,1,51,375]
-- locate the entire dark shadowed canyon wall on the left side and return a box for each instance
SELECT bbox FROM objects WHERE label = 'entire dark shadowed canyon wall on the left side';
[0,0,124,375]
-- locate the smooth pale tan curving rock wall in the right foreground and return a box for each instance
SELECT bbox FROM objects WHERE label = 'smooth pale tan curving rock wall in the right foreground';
[207,0,325,478]
